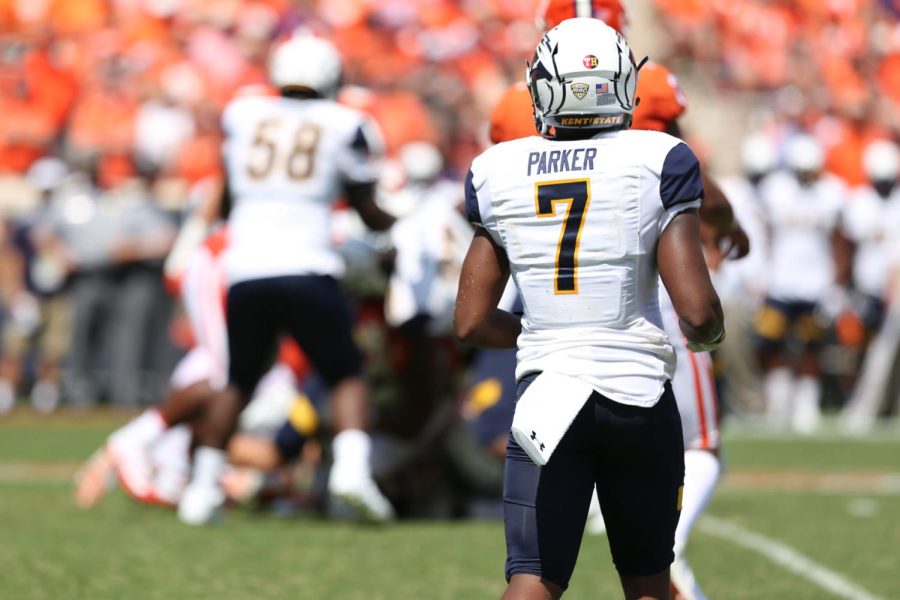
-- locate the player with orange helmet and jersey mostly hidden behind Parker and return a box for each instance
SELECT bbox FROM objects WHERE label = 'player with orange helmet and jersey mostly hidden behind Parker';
[492,5,749,600]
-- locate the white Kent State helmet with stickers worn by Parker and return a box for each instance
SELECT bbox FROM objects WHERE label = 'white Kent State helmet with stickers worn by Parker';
[525,18,643,135]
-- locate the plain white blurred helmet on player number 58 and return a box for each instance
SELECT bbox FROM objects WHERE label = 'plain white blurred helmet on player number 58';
[269,34,341,98]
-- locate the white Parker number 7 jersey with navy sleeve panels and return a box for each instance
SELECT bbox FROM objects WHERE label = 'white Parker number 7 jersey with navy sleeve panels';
[466,130,703,406]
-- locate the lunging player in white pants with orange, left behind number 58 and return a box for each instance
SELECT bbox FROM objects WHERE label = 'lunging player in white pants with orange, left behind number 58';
[76,223,320,508]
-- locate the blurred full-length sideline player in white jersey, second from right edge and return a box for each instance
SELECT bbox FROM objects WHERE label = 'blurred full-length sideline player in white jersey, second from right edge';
[756,134,847,433]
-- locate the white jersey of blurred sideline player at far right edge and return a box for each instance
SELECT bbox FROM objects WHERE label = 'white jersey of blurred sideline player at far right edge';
[842,186,900,298]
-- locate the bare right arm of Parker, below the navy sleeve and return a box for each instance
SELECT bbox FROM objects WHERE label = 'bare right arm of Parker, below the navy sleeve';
[656,210,725,349]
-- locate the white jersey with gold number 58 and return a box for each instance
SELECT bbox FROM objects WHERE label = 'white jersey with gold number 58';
[223,97,381,284]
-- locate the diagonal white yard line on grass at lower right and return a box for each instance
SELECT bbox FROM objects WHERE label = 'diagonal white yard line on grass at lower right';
[697,515,881,600]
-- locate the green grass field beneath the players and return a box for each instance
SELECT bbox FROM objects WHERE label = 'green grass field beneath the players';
[0,415,900,600]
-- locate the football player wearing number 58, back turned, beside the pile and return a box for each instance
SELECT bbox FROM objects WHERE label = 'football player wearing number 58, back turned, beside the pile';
[178,35,394,524]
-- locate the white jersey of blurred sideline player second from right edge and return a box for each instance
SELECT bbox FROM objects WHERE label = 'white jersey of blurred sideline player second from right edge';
[760,172,846,302]
